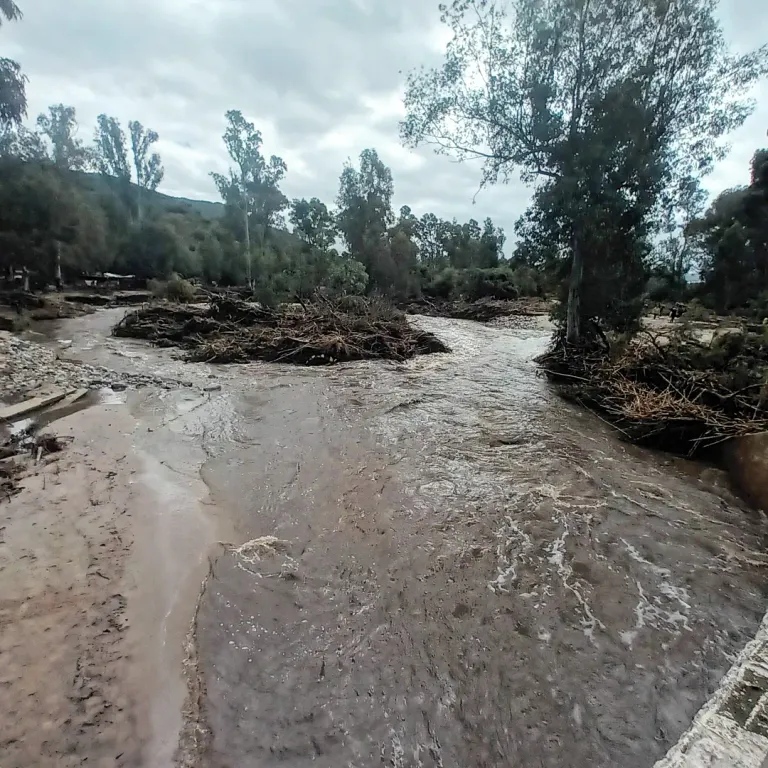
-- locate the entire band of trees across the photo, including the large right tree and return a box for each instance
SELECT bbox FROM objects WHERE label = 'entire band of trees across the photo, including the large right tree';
[0,0,768,318]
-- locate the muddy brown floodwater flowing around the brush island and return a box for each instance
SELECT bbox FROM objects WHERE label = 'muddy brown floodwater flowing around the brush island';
[51,312,765,768]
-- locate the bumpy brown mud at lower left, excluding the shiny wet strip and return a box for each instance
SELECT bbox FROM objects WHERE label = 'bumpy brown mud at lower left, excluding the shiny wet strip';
[0,407,152,768]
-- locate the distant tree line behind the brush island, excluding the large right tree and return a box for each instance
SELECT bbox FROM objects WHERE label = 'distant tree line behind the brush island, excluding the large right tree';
[0,5,511,299]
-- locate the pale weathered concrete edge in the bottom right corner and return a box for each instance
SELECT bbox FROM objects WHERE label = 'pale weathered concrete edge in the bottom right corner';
[654,613,768,768]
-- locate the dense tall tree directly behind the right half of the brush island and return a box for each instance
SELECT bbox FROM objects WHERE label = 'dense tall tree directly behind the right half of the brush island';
[336,149,394,290]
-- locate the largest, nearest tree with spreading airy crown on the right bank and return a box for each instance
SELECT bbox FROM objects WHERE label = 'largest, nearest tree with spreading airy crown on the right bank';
[402,0,768,341]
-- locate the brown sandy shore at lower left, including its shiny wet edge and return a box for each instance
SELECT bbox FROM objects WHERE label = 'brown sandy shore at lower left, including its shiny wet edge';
[0,405,216,768]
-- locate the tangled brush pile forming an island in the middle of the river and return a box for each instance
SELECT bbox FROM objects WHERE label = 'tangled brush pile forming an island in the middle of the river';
[112,295,450,365]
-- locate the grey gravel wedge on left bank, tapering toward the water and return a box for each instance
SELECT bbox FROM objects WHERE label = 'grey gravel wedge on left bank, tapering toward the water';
[0,333,190,400]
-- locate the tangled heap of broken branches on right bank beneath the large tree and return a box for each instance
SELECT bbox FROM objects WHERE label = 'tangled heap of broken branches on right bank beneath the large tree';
[538,330,768,455]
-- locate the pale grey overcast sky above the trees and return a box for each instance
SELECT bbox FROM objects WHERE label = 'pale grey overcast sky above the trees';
[0,0,768,244]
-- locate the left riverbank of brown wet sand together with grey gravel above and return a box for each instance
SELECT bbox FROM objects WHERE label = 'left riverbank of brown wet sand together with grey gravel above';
[0,326,225,768]
